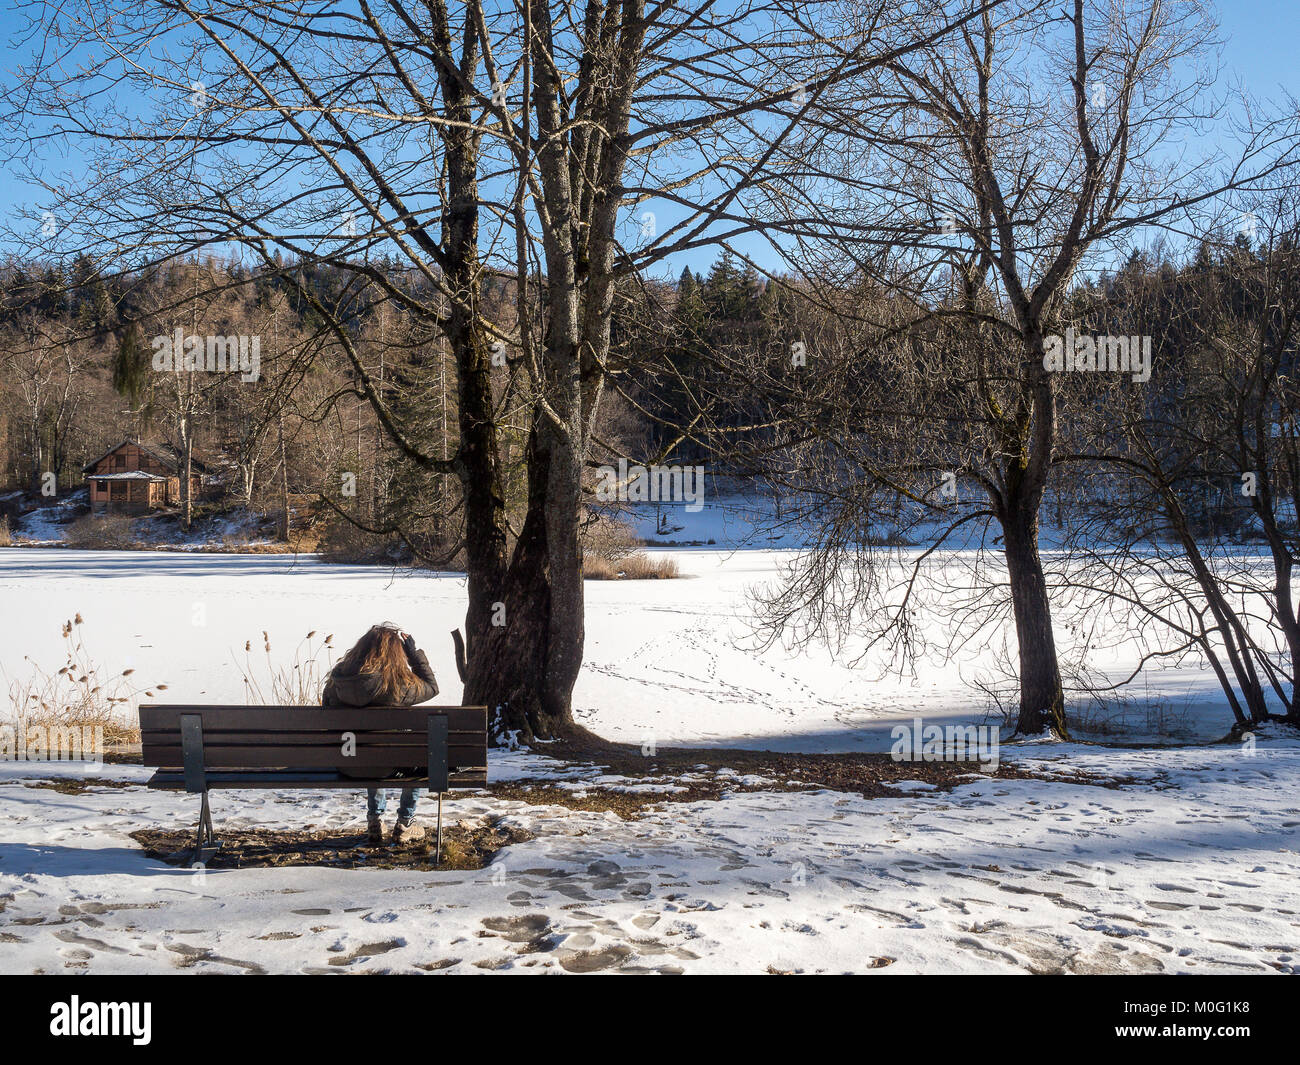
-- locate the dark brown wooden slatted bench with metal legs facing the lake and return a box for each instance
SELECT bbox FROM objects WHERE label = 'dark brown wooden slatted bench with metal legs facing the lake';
[140,706,488,863]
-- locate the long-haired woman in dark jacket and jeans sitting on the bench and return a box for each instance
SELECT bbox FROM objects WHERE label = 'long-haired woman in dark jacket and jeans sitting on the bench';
[321,622,438,843]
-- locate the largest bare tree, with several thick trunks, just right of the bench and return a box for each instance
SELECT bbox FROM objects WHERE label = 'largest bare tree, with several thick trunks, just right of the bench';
[7,0,1001,739]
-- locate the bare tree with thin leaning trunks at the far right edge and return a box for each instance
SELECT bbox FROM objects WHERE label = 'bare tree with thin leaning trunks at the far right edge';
[1070,204,1300,727]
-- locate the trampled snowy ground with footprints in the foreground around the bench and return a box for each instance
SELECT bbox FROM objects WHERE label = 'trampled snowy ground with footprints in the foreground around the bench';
[0,743,1300,974]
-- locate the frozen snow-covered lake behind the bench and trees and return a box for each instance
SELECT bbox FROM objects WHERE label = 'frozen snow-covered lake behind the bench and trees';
[0,547,1231,752]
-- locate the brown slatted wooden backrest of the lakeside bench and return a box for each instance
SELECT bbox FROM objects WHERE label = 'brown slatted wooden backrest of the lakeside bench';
[140,705,488,772]
